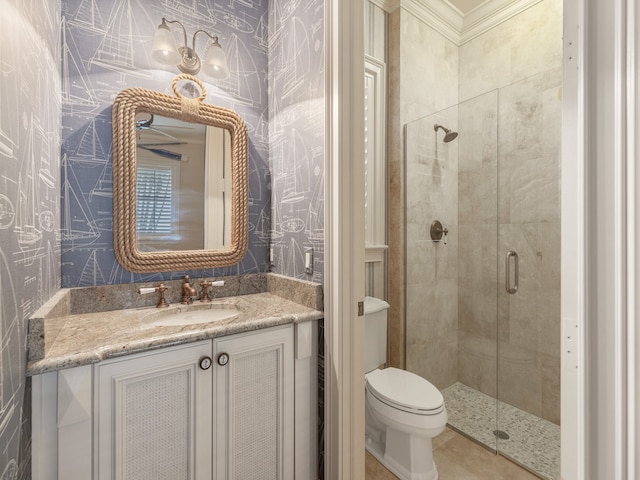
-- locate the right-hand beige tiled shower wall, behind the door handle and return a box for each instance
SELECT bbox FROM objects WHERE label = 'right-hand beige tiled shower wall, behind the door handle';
[458,0,562,423]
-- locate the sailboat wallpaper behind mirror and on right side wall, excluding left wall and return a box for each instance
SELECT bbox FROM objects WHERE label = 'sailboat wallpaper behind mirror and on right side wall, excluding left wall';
[61,0,324,287]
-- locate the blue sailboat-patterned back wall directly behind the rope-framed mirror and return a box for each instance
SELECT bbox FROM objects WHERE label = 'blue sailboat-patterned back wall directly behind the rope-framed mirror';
[61,0,271,287]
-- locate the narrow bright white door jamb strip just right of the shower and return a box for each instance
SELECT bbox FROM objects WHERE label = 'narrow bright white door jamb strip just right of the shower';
[560,2,587,480]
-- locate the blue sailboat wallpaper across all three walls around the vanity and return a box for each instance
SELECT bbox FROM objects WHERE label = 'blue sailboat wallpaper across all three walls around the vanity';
[0,0,325,474]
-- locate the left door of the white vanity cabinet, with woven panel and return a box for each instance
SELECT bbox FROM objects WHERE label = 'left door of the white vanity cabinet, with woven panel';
[95,341,213,480]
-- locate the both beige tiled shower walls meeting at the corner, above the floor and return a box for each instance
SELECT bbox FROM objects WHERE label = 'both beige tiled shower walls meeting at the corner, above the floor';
[389,0,562,422]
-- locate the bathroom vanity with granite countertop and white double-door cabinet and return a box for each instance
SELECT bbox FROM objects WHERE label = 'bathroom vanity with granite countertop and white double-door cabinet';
[29,274,323,480]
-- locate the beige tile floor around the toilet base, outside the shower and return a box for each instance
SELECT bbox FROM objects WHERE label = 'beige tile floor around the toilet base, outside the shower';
[365,428,538,480]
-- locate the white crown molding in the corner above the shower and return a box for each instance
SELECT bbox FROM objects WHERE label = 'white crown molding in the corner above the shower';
[369,0,542,46]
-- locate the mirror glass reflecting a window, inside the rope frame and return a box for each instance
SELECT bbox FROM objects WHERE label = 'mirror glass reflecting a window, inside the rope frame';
[136,112,231,252]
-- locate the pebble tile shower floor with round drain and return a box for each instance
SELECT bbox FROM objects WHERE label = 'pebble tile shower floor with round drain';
[442,383,560,480]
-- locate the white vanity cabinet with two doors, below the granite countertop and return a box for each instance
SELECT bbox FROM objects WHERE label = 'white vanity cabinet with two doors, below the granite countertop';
[33,322,317,480]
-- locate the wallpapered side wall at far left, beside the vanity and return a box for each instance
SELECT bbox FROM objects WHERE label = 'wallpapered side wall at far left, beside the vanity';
[0,0,60,480]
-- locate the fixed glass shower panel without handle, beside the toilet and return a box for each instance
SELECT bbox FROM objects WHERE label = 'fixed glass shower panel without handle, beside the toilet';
[405,92,498,450]
